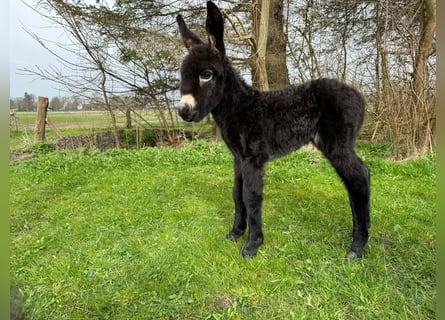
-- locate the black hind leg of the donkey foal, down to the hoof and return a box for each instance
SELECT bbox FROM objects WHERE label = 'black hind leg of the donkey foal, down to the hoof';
[322,147,371,258]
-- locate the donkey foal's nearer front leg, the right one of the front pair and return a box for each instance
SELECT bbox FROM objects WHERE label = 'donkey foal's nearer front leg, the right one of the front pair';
[242,164,264,257]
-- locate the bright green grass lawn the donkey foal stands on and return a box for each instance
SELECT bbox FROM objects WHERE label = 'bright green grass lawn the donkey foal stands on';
[10,142,436,320]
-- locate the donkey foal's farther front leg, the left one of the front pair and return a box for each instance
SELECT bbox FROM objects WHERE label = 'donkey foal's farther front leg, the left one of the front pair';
[227,158,247,241]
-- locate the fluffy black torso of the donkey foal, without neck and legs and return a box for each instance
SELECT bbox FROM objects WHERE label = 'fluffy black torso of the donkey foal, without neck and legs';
[241,78,365,158]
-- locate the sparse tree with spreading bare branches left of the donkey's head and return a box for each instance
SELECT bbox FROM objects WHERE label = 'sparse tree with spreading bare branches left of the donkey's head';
[22,0,179,147]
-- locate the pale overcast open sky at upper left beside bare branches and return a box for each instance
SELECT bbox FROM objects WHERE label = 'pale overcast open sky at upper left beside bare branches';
[9,0,73,99]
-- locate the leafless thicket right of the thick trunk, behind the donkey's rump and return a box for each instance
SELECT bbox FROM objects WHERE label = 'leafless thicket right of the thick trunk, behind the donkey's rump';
[286,0,436,158]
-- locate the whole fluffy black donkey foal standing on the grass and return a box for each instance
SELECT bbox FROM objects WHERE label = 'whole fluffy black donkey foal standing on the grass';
[177,1,370,258]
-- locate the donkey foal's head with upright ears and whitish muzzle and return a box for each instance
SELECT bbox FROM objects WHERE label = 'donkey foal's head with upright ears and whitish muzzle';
[176,1,225,122]
